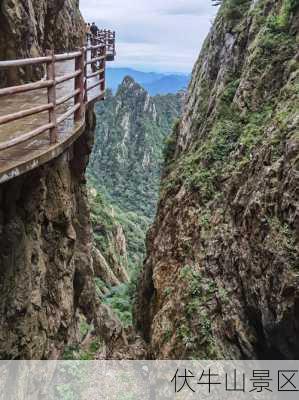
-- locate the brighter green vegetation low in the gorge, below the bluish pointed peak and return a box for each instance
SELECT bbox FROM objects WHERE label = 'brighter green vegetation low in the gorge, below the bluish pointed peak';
[89,184,149,327]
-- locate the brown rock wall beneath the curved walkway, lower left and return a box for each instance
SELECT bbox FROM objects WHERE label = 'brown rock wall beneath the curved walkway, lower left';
[0,110,98,359]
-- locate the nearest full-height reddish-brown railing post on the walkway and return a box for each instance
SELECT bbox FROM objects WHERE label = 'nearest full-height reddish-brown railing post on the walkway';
[46,50,58,144]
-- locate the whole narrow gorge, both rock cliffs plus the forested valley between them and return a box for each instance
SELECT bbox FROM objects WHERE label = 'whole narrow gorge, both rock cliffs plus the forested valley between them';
[0,0,299,360]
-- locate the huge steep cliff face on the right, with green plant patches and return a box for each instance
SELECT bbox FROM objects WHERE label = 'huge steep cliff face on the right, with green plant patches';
[136,0,299,359]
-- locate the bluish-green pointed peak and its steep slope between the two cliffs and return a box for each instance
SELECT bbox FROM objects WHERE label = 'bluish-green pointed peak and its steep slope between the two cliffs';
[89,77,182,218]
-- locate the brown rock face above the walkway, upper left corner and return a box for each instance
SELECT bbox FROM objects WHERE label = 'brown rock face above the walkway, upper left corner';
[0,0,85,83]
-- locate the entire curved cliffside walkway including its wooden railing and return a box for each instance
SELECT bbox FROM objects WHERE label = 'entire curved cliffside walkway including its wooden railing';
[0,31,115,183]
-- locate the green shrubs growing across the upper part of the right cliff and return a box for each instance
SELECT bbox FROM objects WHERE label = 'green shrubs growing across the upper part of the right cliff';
[162,0,298,204]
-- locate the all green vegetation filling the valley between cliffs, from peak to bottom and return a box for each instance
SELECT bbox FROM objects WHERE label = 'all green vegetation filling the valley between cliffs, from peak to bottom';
[88,78,182,327]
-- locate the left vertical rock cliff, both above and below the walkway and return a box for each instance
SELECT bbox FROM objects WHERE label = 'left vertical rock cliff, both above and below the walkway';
[0,0,111,359]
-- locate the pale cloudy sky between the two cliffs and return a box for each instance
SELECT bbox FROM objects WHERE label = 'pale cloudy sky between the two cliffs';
[80,0,217,73]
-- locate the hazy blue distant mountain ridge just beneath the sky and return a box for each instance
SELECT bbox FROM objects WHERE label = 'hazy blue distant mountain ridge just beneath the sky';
[107,68,190,96]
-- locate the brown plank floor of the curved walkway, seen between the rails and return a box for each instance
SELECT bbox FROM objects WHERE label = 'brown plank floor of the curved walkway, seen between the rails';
[0,31,115,183]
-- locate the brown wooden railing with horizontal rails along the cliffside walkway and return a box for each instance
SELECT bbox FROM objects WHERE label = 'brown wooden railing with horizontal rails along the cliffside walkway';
[0,31,115,150]
